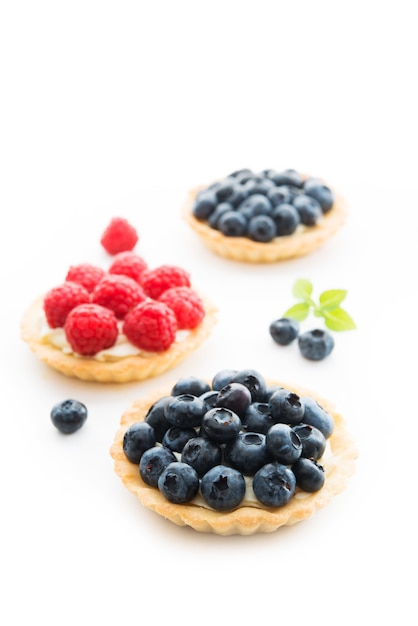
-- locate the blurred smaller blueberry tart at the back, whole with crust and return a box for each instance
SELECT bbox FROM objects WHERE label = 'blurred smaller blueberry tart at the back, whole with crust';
[183,169,346,263]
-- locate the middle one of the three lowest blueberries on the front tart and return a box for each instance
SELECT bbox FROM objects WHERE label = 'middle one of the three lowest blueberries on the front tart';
[200,465,246,511]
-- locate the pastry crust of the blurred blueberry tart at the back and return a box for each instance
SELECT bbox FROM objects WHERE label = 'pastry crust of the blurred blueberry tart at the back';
[183,185,347,263]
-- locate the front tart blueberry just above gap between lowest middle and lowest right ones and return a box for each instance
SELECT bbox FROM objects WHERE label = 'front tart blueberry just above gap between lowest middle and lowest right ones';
[224,432,271,476]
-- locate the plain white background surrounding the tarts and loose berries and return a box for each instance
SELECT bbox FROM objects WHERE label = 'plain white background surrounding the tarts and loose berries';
[0,0,418,626]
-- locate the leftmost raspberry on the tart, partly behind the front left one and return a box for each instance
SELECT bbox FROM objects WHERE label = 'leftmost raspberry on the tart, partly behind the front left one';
[44,281,90,328]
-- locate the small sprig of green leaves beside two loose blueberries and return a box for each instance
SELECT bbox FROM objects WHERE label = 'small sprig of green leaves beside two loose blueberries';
[283,278,356,331]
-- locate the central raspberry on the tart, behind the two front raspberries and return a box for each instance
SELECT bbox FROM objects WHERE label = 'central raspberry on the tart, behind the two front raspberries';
[91,274,147,320]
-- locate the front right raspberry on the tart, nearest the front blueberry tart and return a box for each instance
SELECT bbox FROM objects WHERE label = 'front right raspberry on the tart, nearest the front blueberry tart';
[123,301,177,352]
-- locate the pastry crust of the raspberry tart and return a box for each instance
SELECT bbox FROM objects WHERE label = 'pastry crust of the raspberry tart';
[21,297,217,383]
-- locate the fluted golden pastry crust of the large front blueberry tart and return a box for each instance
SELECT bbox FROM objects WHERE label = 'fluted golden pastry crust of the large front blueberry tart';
[110,381,357,535]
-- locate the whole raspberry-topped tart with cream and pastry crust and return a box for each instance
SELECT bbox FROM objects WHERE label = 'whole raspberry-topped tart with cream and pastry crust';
[21,251,216,383]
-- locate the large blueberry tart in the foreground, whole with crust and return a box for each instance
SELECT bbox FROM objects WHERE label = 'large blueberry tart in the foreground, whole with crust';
[110,369,357,535]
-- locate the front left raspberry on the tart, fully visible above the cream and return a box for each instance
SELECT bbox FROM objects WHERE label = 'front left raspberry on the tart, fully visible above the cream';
[64,304,118,356]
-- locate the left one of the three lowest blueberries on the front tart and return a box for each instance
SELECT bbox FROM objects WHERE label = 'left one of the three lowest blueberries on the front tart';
[158,461,199,504]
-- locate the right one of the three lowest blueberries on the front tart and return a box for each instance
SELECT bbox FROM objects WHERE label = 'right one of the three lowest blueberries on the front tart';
[253,461,296,506]
